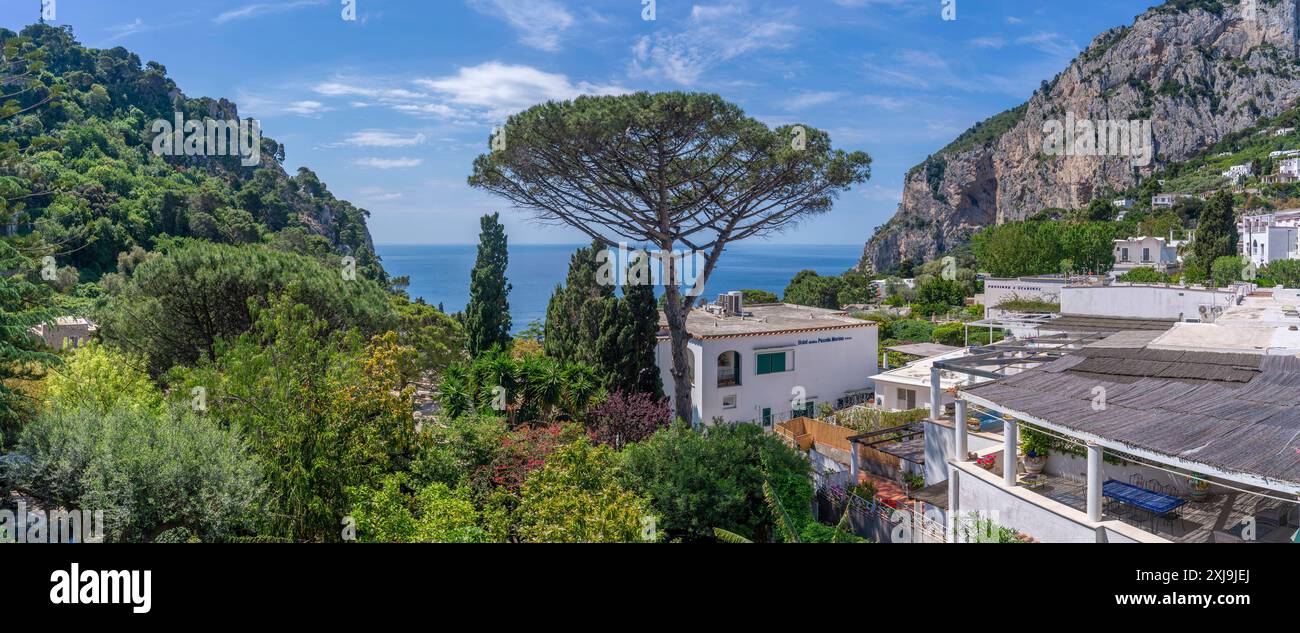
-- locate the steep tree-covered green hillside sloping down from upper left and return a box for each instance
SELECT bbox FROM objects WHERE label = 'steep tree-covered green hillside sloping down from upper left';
[0,25,385,282]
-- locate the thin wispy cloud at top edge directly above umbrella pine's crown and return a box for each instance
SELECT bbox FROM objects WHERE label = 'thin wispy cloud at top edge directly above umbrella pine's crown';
[631,1,798,86]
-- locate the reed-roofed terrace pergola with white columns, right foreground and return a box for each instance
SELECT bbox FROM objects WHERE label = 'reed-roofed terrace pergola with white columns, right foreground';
[931,333,1300,532]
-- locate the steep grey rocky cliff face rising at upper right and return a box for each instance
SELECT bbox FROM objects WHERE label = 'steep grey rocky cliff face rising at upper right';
[861,0,1300,272]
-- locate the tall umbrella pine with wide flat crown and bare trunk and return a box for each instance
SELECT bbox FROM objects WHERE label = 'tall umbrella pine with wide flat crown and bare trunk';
[469,92,871,420]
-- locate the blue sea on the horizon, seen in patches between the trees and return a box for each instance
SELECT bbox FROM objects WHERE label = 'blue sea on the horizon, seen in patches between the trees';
[374,243,862,333]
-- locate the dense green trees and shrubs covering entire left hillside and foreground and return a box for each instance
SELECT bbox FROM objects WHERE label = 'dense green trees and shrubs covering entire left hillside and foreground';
[0,26,873,542]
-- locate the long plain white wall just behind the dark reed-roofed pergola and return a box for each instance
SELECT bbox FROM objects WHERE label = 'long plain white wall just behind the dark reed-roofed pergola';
[1061,283,1232,320]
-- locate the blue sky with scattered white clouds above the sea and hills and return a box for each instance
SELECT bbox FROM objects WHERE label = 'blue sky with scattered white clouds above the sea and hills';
[0,0,1158,243]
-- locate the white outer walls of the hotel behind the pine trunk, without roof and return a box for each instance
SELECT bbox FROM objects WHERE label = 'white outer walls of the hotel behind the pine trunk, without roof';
[657,322,879,424]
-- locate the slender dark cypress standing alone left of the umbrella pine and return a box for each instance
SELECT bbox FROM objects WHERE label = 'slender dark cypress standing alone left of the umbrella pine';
[465,213,511,356]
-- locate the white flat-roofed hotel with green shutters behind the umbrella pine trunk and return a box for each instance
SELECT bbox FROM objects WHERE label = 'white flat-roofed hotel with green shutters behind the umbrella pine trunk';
[655,292,879,428]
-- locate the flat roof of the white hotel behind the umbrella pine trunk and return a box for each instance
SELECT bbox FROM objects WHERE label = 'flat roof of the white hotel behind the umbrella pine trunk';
[659,303,876,338]
